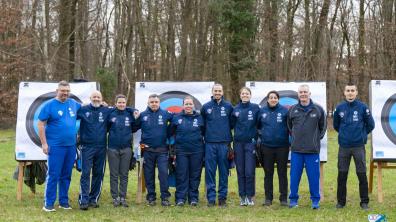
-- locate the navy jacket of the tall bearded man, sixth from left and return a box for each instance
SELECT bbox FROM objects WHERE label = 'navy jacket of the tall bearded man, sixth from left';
[201,97,233,143]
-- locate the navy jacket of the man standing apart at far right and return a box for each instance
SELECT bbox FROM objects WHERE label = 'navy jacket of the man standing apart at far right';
[333,100,375,148]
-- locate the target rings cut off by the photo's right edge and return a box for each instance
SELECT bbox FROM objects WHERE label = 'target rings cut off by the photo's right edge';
[381,94,396,145]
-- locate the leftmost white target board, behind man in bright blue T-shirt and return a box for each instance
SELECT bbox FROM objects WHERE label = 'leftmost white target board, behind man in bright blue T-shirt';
[15,82,97,161]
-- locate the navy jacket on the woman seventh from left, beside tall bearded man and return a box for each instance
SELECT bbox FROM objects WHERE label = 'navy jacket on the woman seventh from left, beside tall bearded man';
[231,102,260,143]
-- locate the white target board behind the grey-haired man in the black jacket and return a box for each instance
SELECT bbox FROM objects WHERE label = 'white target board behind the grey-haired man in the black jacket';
[246,81,327,162]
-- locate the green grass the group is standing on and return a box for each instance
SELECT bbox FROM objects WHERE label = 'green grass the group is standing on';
[0,130,396,221]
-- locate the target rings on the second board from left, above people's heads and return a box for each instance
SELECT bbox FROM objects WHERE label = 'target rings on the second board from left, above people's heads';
[159,91,202,113]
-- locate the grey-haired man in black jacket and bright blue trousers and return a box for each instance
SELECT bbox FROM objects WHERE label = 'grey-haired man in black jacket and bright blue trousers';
[287,84,326,209]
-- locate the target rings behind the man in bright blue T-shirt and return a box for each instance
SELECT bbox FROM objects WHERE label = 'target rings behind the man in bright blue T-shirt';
[25,92,82,147]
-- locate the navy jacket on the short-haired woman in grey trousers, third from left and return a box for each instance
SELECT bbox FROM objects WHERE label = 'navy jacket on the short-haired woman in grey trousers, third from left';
[107,109,137,149]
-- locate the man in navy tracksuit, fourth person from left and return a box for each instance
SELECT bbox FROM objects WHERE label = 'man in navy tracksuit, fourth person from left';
[138,94,173,206]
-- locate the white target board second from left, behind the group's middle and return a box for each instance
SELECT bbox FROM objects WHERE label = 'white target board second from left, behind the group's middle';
[133,82,214,148]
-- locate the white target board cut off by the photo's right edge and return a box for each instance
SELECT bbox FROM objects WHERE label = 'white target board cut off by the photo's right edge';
[370,80,396,161]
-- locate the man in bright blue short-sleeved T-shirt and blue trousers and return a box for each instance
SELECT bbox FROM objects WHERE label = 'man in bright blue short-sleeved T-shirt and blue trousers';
[38,81,81,212]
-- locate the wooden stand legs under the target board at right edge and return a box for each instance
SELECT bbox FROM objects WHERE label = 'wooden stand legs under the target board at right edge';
[369,156,396,203]
